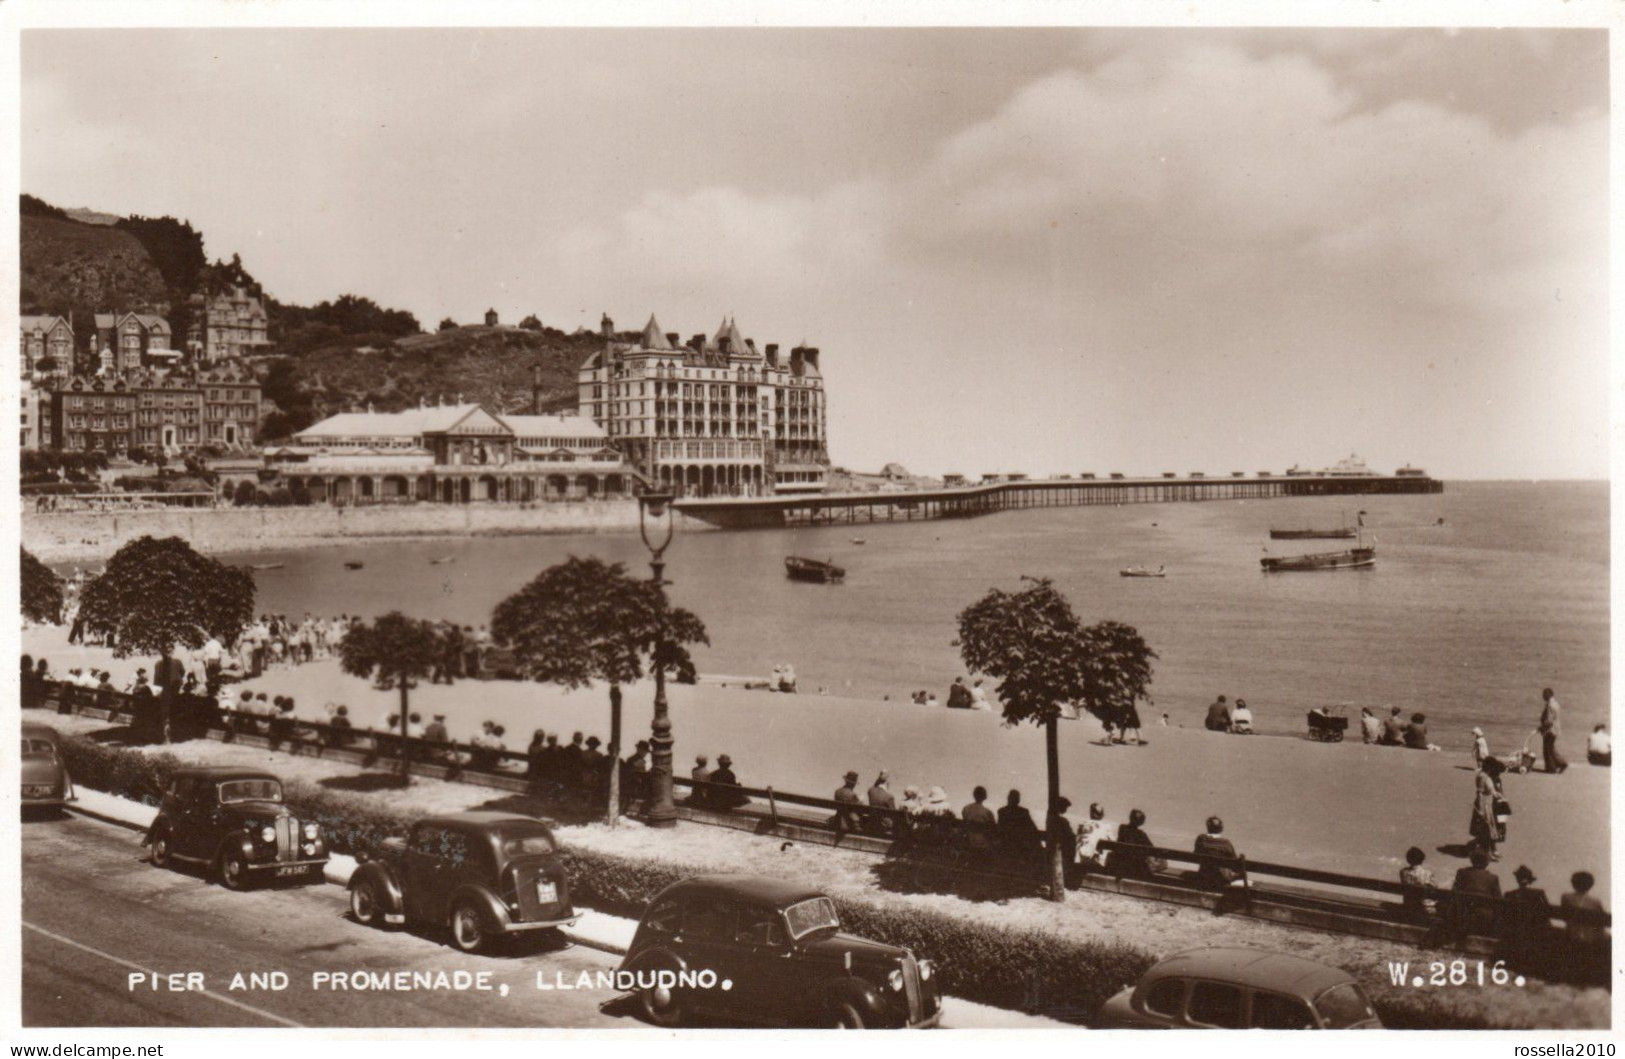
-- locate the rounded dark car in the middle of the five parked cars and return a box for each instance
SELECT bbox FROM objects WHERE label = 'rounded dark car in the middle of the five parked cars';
[349,812,575,952]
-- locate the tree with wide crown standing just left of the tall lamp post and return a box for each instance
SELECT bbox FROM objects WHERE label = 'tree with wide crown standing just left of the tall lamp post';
[491,555,710,823]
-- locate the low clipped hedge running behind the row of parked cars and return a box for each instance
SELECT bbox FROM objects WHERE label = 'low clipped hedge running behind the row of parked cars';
[50,736,1497,1030]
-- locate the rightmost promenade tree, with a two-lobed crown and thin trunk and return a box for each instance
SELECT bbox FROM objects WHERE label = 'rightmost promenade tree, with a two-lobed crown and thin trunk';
[956,578,1157,901]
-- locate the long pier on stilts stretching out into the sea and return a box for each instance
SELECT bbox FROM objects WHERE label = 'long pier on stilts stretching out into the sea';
[674,474,1445,530]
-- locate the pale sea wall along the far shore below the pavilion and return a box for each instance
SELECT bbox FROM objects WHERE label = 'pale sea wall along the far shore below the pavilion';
[23,500,713,562]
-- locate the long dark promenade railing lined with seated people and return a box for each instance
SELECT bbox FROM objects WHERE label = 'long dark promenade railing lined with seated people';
[23,669,1614,973]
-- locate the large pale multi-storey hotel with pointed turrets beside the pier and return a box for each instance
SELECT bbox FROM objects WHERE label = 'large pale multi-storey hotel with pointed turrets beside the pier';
[575,315,829,497]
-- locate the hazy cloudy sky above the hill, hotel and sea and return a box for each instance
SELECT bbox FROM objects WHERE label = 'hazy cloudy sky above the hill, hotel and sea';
[21,28,1609,478]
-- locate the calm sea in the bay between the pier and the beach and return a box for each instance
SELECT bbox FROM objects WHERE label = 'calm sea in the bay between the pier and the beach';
[212,482,1609,754]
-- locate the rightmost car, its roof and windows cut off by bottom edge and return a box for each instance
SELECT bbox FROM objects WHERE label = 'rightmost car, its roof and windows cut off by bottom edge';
[1094,949,1383,1030]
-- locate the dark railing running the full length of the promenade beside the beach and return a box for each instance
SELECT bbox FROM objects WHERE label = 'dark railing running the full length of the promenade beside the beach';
[23,679,1612,958]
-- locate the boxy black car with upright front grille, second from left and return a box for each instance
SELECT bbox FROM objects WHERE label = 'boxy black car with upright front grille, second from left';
[146,767,327,890]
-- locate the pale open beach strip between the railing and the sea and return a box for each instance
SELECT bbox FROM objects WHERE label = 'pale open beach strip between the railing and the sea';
[23,627,1610,898]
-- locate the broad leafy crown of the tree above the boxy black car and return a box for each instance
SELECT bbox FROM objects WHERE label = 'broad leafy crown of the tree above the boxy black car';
[80,536,254,658]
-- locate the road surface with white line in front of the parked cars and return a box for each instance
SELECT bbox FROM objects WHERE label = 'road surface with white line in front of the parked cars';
[23,815,644,1028]
